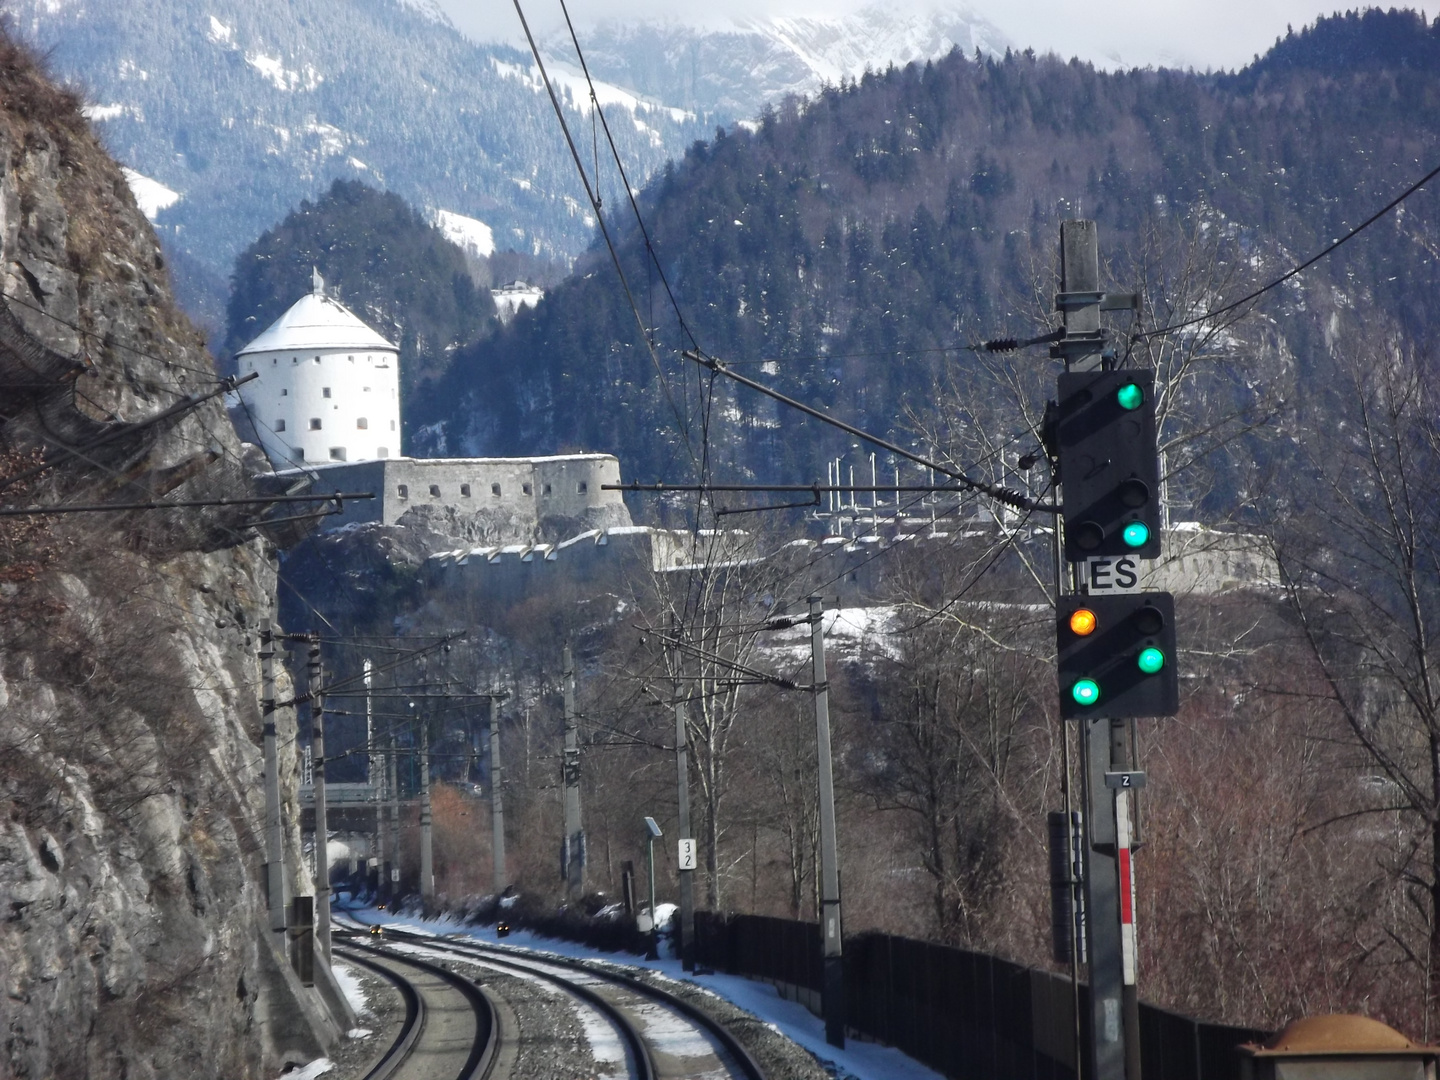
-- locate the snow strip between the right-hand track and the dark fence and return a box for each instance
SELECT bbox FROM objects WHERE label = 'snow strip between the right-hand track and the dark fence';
[336,904,945,1080]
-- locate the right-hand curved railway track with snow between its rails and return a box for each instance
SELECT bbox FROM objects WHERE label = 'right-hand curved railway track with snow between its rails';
[338,927,766,1080]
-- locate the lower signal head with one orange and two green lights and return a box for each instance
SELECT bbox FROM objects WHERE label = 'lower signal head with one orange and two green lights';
[1056,592,1179,720]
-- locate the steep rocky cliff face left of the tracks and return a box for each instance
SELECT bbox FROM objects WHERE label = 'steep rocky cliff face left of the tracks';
[0,35,334,1077]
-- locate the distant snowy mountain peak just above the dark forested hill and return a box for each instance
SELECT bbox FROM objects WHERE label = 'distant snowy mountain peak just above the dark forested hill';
[546,3,1009,120]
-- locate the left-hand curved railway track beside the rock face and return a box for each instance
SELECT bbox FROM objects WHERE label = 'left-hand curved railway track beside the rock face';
[334,937,498,1080]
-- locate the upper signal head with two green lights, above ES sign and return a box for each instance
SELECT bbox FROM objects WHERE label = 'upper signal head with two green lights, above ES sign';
[1053,370,1161,562]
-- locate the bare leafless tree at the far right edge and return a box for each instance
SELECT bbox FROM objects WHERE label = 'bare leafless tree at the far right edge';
[1272,327,1440,1038]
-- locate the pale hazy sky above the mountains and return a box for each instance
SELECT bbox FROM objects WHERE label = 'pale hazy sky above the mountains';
[439,0,1390,69]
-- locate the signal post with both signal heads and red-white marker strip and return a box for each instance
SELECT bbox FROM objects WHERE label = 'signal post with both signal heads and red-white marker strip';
[1044,222,1179,1080]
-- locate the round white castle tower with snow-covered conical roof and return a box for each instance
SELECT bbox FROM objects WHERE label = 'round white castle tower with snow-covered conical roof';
[236,271,400,467]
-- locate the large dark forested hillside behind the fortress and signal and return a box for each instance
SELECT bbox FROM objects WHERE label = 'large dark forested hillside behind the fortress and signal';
[423,12,1440,495]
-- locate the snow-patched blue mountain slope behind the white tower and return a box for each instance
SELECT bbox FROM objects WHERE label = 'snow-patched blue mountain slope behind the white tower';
[4,0,705,279]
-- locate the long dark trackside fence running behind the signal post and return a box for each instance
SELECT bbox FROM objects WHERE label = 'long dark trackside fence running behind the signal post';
[696,912,1267,1080]
